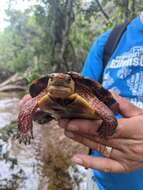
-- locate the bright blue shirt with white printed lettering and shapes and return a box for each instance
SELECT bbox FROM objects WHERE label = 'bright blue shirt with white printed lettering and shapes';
[82,17,143,190]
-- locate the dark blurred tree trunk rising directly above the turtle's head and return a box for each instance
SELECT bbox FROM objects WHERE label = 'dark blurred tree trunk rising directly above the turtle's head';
[49,0,75,72]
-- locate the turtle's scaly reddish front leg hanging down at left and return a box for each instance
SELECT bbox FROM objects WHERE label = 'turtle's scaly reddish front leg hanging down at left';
[16,98,38,144]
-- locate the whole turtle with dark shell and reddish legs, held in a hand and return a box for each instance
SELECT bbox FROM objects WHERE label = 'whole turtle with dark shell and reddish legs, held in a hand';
[17,71,119,144]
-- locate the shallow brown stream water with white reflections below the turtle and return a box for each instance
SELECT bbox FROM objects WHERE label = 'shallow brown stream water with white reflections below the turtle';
[0,93,86,190]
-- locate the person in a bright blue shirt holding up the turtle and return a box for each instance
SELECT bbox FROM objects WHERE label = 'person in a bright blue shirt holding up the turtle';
[59,13,143,190]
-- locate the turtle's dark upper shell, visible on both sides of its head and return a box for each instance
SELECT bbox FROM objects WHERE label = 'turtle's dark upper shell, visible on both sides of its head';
[29,71,118,113]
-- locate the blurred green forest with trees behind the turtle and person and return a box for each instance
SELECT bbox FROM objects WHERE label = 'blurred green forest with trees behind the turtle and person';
[0,0,143,81]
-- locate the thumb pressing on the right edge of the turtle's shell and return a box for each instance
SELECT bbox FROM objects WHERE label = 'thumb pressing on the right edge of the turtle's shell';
[112,92,143,117]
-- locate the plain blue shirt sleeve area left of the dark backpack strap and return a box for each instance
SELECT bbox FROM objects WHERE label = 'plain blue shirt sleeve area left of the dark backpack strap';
[81,30,111,81]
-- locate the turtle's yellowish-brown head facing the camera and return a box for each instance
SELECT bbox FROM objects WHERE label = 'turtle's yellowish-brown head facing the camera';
[47,73,75,98]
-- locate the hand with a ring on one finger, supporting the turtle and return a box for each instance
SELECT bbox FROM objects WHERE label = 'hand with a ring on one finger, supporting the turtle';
[59,95,143,172]
